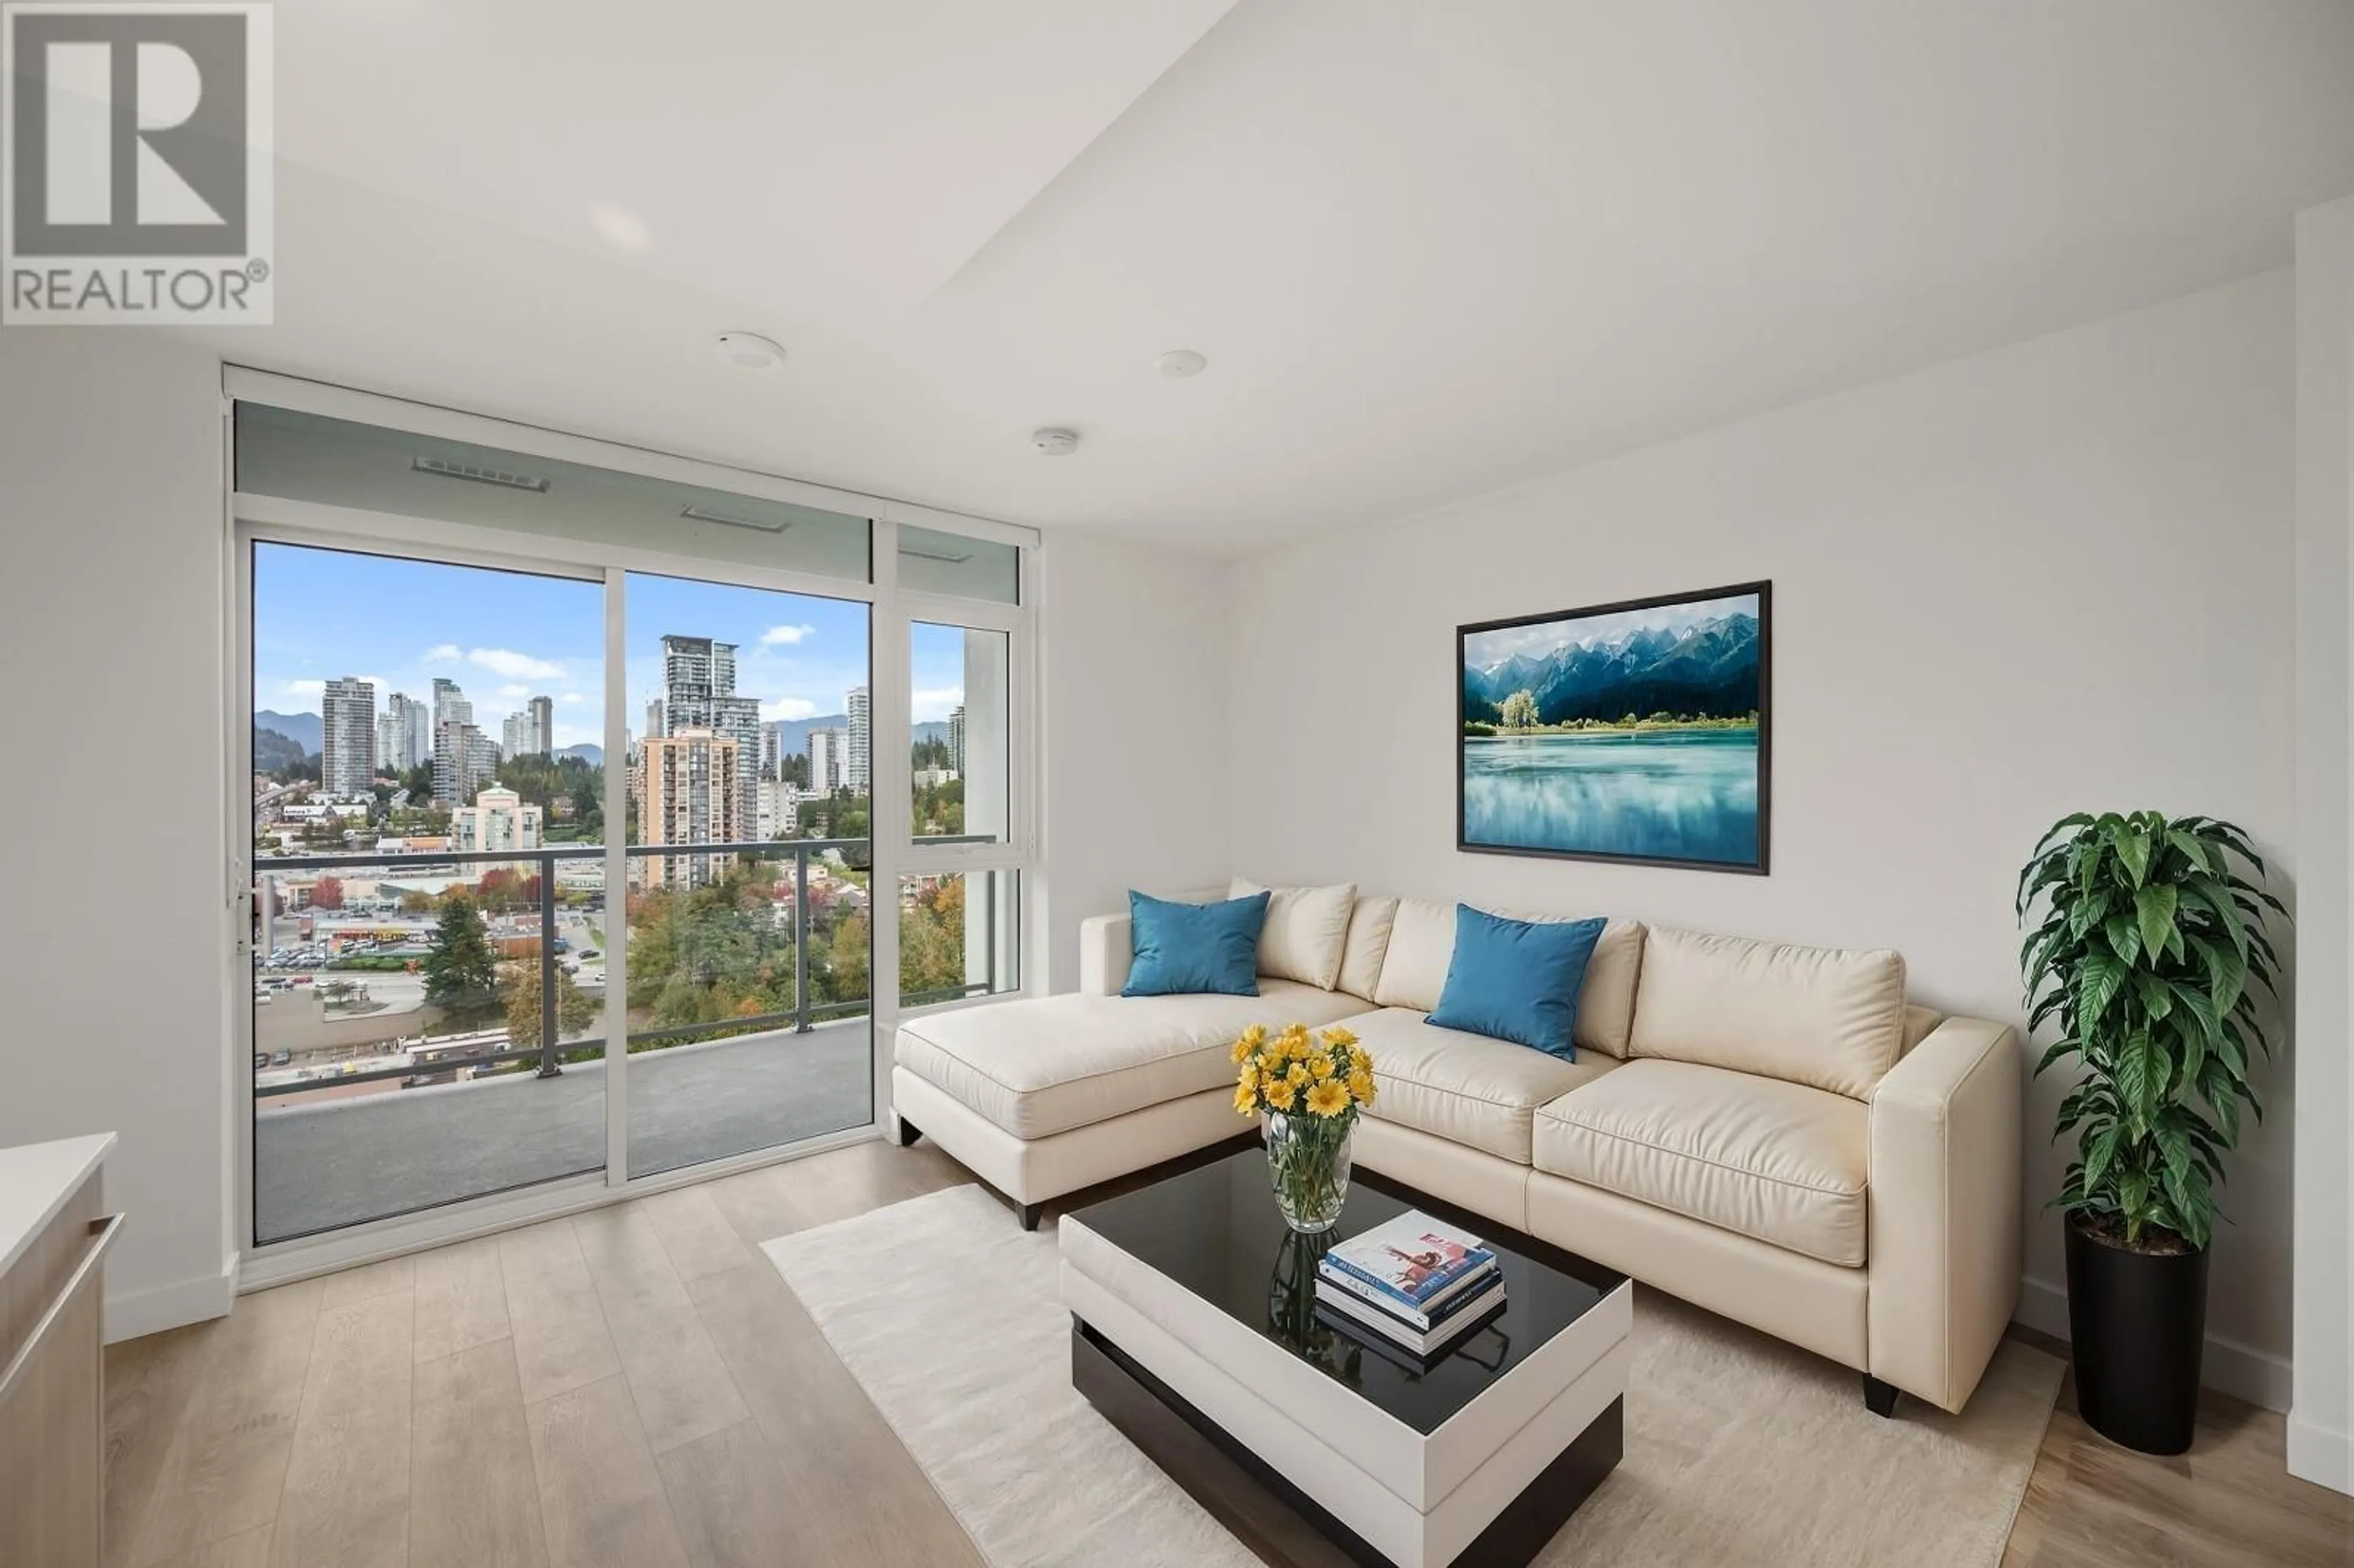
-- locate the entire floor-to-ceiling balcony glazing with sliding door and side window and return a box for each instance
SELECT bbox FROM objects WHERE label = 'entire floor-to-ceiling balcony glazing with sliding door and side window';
[230,372,1036,1279]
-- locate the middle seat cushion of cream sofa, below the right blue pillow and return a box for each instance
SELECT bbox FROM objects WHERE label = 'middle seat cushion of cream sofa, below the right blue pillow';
[1349,1008,1617,1165]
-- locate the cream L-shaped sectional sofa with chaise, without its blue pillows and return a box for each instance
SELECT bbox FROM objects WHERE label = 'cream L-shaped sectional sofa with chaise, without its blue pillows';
[892,890,2024,1415]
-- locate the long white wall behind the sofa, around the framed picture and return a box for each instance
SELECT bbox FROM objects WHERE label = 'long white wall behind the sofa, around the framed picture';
[1228,273,2293,1406]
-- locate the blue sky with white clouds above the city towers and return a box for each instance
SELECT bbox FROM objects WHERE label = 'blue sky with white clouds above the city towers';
[254,544,965,747]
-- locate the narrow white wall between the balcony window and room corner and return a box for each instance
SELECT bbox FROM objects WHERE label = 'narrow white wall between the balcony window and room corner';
[1034,530,1228,991]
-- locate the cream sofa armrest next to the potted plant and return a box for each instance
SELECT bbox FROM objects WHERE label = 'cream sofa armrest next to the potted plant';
[1864,1017,2022,1410]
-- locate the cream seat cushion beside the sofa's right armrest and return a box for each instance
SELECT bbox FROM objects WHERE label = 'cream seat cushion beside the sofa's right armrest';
[1533,1062,1872,1269]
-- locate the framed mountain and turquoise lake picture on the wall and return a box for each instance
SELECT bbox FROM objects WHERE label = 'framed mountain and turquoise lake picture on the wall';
[1457,582,1773,873]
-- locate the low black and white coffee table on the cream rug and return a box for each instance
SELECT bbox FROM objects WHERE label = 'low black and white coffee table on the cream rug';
[1062,1146,1634,1568]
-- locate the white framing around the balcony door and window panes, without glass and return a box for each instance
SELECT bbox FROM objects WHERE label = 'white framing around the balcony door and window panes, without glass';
[221,365,1045,1288]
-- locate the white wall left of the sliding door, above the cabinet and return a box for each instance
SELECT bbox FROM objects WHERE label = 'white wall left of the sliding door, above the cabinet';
[0,327,230,1338]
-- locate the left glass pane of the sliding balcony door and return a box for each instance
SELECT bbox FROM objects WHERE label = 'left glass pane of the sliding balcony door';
[249,541,605,1246]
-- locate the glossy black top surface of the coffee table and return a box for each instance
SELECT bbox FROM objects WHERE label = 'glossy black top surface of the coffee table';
[1073,1149,1625,1434]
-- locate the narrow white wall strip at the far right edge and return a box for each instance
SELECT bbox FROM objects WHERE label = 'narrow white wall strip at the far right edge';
[2288,200,2354,1490]
